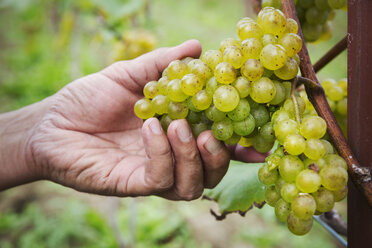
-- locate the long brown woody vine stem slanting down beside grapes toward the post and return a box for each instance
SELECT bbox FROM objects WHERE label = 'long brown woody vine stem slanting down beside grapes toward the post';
[281,0,372,208]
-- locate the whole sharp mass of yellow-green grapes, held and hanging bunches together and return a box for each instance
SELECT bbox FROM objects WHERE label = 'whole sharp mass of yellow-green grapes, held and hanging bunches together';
[134,7,348,235]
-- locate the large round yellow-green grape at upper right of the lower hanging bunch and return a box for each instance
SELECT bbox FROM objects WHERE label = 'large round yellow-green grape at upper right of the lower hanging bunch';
[300,116,327,139]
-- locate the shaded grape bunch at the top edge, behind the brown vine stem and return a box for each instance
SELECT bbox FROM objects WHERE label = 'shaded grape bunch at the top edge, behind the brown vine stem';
[262,0,347,42]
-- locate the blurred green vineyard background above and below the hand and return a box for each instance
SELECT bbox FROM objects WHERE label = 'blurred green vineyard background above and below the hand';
[0,0,347,248]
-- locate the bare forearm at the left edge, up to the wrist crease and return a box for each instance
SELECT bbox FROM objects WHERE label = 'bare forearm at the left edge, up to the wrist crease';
[0,98,49,190]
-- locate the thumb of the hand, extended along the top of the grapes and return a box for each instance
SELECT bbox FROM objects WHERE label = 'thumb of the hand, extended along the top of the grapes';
[101,40,201,91]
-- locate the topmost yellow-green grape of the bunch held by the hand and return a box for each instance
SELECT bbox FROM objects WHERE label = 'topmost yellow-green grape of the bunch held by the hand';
[257,9,287,35]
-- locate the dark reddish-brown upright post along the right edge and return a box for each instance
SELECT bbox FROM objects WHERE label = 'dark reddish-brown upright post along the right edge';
[347,0,372,248]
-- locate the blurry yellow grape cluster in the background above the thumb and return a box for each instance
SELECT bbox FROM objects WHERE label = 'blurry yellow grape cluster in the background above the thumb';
[114,29,156,60]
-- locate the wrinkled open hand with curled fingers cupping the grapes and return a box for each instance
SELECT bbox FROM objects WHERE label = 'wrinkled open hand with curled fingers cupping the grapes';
[29,40,263,200]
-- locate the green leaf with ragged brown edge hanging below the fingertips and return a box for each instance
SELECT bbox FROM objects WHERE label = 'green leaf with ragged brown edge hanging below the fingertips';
[205,161,265,213]
